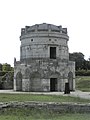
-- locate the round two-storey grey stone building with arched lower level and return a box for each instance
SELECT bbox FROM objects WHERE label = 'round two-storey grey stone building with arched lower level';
[14,23,75,91]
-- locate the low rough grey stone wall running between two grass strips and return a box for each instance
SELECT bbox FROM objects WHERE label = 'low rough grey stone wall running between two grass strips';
[0,102,90,113]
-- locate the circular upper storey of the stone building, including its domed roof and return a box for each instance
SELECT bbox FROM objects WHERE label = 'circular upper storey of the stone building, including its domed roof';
[20,23,69,60]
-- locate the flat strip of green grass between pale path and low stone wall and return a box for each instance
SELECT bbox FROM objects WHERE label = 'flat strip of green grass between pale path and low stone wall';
[0,93,90,103]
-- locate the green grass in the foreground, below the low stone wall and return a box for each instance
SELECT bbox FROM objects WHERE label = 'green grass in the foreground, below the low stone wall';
[0,108,90,120]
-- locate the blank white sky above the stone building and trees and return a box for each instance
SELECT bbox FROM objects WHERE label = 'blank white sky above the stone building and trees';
[0,0,90,66]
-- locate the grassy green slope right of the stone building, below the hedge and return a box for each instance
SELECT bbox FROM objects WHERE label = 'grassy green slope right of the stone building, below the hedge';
[76,76,90,92]
